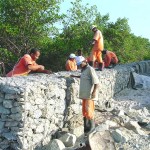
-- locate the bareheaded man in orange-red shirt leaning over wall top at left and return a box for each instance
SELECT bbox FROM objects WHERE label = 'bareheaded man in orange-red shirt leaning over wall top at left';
[6,48,51,77]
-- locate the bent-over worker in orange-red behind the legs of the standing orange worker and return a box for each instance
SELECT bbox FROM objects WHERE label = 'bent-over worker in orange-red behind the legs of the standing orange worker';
[102,50,118,68]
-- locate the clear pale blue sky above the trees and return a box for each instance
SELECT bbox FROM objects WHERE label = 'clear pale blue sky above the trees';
[61,0,150,40]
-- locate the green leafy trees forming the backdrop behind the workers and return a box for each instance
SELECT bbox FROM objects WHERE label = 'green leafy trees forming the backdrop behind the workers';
[0,0,150,71]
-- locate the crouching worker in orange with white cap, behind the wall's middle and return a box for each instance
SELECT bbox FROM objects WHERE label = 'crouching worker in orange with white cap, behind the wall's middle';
[65,53,77,71]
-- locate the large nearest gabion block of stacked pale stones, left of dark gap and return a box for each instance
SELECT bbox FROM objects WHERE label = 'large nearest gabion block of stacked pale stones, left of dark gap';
[0,74,66,150]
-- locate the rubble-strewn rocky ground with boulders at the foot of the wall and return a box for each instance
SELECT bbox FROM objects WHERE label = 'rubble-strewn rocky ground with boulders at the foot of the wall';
[46,73,150,150]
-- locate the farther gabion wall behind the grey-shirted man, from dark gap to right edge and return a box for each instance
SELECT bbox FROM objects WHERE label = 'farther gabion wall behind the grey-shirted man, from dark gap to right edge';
[60,61,150,124]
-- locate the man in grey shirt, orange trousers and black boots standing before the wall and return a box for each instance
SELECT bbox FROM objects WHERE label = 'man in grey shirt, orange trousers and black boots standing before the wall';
[71,58,99,135]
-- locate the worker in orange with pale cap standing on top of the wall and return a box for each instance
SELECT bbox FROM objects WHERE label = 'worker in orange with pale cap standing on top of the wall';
[89,25,104,71]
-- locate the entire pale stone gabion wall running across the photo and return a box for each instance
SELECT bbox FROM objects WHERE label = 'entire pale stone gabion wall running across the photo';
[0,61,150,150]
